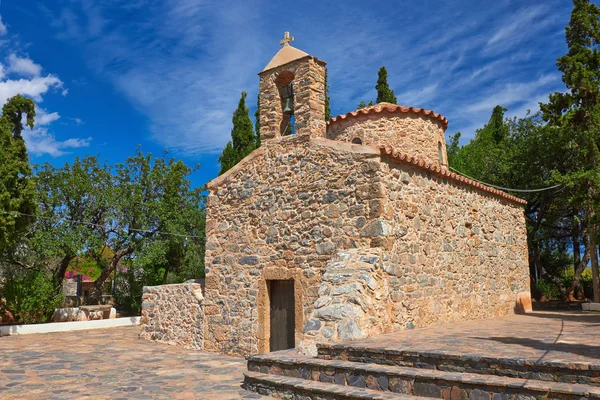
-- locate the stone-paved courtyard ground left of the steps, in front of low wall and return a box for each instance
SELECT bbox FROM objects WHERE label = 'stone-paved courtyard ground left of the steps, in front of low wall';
[0,327,265,400]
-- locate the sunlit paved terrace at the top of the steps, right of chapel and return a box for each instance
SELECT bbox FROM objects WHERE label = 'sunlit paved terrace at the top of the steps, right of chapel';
[326,312,600,368]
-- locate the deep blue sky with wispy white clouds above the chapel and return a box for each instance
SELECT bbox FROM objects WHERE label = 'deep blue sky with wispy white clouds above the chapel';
[0,0,572,185]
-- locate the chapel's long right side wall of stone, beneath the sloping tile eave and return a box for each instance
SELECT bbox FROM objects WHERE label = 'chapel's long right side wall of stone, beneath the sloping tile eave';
[384,160,529,330]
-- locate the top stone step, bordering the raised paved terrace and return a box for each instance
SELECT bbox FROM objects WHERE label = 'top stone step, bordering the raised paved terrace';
[317,344,600,386]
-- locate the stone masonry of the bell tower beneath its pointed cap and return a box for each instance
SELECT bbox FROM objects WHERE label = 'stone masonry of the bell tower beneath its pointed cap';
[259,56,327,143]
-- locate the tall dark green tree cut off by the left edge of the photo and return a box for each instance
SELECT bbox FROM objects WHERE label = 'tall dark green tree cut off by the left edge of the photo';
[0,95,35,254]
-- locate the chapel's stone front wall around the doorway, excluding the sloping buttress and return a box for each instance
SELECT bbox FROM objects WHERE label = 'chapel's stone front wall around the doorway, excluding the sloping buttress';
[205,135,385,354]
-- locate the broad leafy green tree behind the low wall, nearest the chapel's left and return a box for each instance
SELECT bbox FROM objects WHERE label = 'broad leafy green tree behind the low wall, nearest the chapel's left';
[88,151,205,304]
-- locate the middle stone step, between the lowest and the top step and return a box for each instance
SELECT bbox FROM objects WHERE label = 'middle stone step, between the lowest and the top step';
[247,351,600,400]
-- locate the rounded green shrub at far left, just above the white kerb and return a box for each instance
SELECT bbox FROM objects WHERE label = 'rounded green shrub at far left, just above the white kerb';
[3,271,63,324]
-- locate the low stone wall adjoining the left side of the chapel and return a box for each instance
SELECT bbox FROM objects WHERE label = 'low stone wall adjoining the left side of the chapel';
[140,283,204,350]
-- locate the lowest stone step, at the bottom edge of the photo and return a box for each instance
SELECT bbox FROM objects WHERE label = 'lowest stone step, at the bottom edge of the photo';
[244,371,428,400]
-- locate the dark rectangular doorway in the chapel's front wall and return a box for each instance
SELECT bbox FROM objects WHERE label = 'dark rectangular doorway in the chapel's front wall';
[268,281,296,351]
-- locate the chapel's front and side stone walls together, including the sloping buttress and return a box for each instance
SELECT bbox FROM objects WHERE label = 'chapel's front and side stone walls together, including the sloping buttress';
[204,135,529,355]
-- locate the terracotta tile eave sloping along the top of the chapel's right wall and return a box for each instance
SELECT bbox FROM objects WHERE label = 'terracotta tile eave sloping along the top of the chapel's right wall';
[379,146,527,205]
